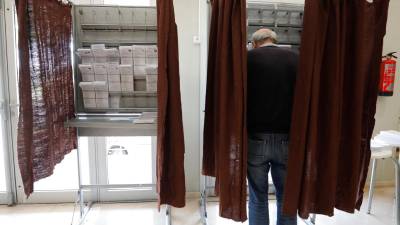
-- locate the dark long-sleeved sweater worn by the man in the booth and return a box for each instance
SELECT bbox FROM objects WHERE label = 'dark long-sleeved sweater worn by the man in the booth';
[247,46,298,133]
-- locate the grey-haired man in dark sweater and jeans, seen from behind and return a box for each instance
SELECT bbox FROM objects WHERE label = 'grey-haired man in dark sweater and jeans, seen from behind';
[247,29,298,225]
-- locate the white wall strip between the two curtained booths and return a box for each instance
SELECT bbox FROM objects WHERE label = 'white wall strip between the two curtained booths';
[174,0,205,192]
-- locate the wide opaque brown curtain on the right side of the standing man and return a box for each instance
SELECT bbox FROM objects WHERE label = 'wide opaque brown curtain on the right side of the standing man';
[284,0,389,218]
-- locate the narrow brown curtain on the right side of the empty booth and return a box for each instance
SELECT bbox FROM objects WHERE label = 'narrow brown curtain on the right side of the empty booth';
[157,0,186,207]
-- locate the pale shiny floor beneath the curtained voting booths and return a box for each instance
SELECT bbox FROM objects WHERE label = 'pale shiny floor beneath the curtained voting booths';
[0,188,394,225]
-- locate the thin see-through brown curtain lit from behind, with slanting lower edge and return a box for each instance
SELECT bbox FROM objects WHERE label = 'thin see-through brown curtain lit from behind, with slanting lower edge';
[16,0,76,196]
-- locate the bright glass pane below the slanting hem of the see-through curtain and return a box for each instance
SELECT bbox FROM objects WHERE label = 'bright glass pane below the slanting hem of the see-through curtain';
[34,137,90,191]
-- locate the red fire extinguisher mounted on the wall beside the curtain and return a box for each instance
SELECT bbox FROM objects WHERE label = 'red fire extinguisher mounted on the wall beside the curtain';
[379,52,397,96]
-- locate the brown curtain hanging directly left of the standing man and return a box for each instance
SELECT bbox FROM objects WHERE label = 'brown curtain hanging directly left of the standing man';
[203,0,247,221]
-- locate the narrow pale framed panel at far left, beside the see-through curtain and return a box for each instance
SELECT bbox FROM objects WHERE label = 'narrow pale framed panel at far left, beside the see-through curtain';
[0,0,18,204]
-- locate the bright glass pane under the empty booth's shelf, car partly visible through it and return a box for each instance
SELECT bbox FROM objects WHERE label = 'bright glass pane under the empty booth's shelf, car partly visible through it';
[106,137,153,184]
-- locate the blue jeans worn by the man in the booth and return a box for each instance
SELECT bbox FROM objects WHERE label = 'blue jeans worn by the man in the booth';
[247,134,297,225]
